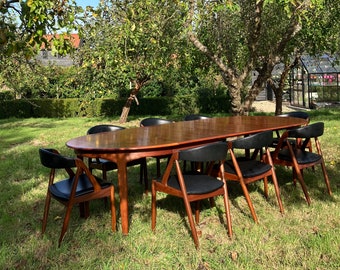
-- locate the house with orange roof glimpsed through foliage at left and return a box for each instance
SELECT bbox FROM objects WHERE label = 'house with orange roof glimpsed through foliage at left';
[35,34,82,67]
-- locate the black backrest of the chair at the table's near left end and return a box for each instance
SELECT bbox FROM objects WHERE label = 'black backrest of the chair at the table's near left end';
[39,148,76,169]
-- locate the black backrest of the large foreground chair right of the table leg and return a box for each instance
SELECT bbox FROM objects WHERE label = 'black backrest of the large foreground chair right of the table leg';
[179,142,227,162]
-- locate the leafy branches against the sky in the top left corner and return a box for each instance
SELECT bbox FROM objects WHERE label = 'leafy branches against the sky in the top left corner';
[0,0,81,58]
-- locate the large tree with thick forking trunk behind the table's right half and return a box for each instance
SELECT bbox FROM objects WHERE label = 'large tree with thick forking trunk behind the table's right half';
[186,0,336,114]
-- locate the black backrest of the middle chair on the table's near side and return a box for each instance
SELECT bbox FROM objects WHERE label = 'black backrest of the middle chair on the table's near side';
[229,131,273,149]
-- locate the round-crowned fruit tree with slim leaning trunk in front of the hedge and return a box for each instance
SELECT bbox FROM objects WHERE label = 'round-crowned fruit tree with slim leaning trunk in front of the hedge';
[78,0,189,123]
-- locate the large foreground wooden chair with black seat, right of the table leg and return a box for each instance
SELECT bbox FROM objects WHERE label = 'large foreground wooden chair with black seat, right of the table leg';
[151,142,232,248]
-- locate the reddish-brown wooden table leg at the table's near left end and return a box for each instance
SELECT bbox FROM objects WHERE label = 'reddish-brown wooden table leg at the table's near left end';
[117,158,129,235]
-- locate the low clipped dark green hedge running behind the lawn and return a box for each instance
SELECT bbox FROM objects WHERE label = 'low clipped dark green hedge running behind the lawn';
[0,96,230,118]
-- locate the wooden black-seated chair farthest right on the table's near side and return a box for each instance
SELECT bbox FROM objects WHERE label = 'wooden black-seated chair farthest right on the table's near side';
[271,122,332,204]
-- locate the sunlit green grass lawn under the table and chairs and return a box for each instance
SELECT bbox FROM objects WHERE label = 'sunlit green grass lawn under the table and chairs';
[0,110,340,269]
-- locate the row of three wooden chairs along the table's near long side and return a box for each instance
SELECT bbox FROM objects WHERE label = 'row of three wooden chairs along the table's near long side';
[151,119,332,247]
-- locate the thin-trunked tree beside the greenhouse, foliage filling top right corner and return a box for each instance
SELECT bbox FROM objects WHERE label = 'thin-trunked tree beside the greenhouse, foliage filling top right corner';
[267,1,340,115]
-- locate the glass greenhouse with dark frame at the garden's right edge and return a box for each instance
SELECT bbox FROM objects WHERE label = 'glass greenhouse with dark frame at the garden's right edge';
[290,54,340,109]
